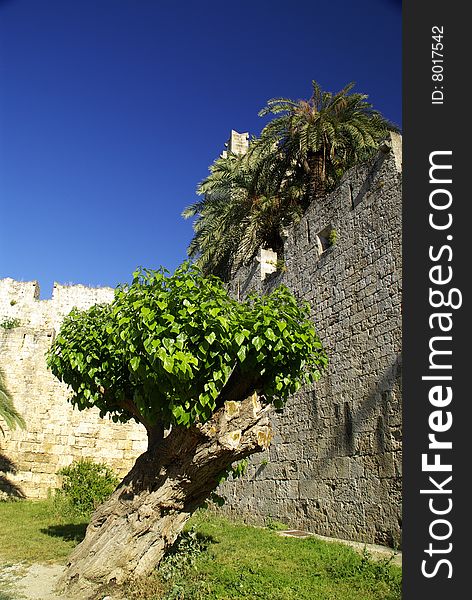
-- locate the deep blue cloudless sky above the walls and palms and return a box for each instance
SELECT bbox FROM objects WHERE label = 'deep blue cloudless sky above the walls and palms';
[0,0,401,297]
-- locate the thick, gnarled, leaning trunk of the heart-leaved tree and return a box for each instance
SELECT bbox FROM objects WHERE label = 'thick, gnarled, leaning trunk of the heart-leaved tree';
[60,395,272,598]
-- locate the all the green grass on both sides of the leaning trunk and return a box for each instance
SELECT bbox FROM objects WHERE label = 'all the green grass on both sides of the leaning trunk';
[0,501,401,600]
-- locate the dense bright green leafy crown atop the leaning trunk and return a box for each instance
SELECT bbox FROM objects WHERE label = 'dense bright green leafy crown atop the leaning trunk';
[48,263,327,433]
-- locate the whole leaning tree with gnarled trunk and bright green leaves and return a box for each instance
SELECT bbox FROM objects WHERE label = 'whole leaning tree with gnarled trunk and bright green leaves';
[48,264,327,586]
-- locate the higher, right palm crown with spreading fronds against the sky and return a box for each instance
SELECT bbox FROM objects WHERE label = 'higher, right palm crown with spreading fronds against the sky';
[258,81,397,197]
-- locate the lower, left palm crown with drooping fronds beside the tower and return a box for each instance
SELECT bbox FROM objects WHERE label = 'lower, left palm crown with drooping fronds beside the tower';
[182,148,304,279]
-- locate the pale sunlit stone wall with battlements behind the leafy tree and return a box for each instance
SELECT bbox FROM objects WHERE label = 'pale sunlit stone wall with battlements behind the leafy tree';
[0,279,146,498]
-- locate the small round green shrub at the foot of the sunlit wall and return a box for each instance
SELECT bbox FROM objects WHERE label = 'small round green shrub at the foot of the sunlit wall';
[58,458,120,516]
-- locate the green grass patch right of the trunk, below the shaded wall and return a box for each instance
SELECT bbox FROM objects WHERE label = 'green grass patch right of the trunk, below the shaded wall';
[123,511,401,600]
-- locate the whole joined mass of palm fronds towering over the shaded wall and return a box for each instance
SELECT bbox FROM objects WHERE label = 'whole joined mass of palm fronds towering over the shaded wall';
[182,81,396,279]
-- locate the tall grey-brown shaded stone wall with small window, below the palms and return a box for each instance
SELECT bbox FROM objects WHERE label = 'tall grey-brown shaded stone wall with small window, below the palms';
[218,135,402,546]
